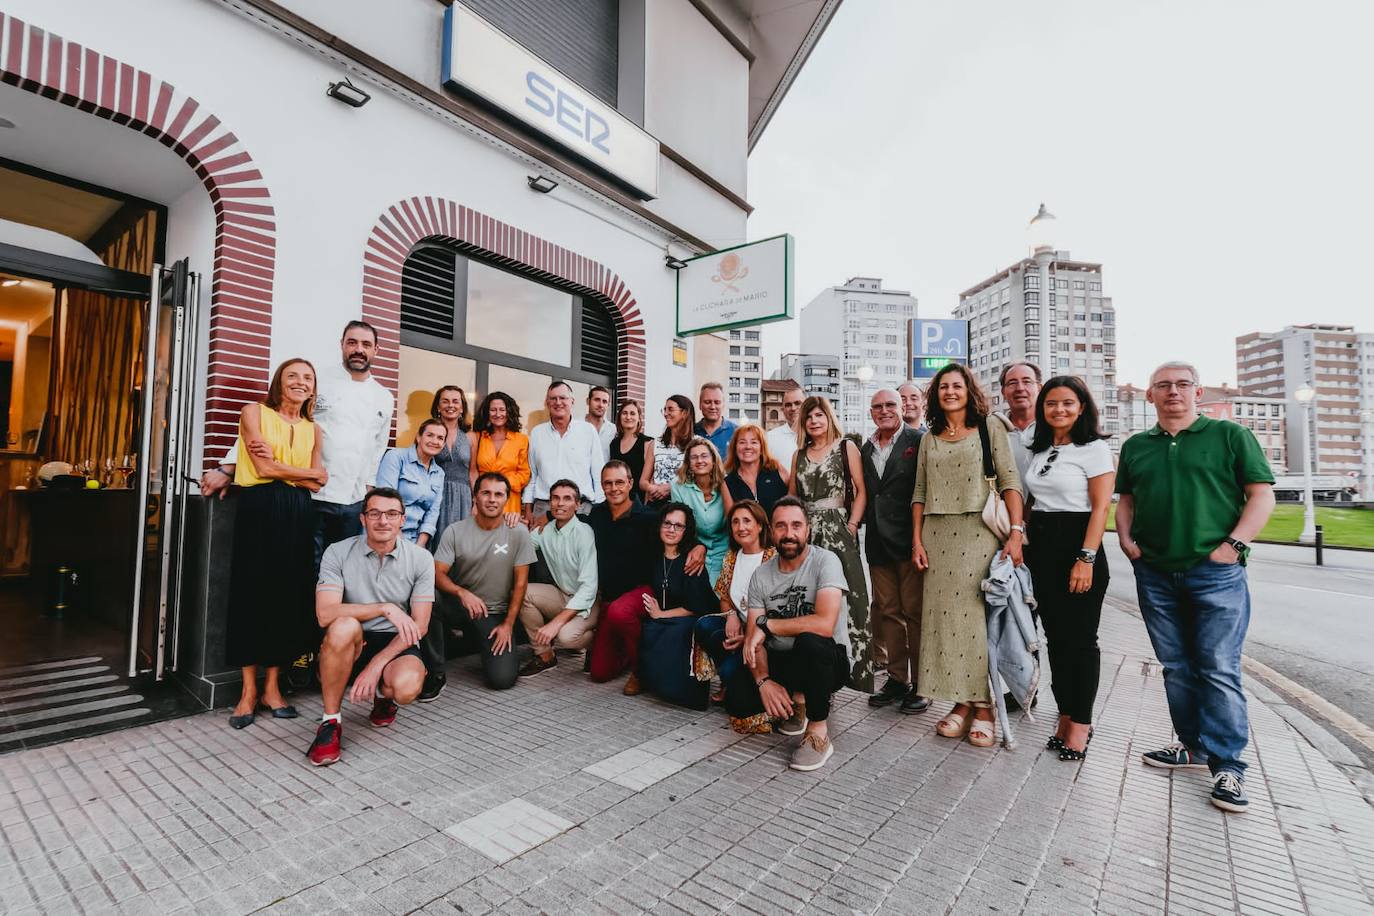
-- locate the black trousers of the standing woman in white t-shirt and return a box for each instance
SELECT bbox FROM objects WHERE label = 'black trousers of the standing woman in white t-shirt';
[1025,512,1110,725]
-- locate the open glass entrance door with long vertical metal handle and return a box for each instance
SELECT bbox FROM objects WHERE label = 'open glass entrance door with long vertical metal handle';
[129,260,201,680]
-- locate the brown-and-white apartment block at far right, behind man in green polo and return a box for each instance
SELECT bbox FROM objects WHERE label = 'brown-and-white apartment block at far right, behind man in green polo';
[1235,324,1374,499]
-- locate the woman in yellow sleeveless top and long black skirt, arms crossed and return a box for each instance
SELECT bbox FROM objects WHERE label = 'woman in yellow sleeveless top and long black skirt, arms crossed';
[225,360,328,728]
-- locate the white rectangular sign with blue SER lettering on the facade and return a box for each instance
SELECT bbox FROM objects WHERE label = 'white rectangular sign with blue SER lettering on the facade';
[442,3,658,199]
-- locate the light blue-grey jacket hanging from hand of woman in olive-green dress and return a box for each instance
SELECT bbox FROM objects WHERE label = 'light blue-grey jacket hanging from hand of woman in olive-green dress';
[982,551,1040,748]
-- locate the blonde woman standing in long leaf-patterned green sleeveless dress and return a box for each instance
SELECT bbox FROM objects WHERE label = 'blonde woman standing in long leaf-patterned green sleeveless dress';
[787,397,872,694]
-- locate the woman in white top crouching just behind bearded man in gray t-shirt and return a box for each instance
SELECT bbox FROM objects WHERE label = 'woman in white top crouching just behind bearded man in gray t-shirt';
[692,500,775,733]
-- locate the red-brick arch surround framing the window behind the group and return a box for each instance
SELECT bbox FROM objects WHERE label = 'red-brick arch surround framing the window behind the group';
[363,196,646,420]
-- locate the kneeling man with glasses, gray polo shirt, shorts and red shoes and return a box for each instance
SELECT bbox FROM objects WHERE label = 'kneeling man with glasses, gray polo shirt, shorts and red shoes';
[305,488,434,766]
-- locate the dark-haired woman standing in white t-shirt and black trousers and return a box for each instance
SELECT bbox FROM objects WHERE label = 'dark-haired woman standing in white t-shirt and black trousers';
[1022,375,1116,761]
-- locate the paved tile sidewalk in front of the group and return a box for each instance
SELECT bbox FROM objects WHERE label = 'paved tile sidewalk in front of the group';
[0,608,1374,915]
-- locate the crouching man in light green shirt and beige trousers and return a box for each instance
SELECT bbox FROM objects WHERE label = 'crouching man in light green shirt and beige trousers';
[519,479,596,677]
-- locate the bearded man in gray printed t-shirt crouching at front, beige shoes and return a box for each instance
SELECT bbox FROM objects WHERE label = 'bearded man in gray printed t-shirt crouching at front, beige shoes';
[725,496,849,770]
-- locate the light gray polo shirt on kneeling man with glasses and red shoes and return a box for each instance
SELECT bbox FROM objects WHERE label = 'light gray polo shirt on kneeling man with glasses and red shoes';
[315,534,434,633]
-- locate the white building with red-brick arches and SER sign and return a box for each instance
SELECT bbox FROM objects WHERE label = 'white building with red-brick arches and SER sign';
[0,0,838,730]
